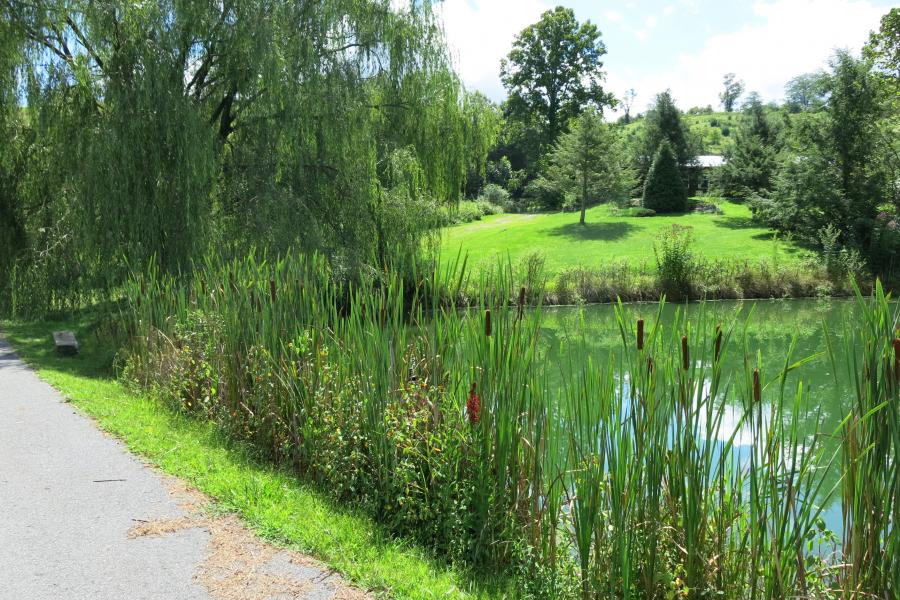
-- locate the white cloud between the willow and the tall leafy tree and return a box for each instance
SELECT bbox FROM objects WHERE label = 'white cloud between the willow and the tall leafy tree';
[437,0,552,100]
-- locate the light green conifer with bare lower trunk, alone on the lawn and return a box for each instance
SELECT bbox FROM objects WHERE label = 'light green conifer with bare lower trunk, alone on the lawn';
[546,109,633,225]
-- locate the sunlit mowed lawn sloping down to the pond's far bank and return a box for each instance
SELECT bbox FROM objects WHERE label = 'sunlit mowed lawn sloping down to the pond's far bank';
[441,201,804,273]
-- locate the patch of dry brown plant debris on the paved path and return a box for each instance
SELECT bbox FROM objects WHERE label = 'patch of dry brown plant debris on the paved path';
[128,476,368,600]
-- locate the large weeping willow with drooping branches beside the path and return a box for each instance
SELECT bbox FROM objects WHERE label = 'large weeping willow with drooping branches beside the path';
[0,0,496,316]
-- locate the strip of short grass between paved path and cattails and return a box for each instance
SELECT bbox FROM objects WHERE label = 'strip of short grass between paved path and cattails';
[0,315,502,598]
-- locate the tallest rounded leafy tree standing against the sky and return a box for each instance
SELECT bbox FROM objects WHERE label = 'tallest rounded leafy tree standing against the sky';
[500,6,615,150]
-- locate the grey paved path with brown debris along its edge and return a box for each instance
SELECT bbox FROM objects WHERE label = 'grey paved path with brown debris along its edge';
[0,338,363,600]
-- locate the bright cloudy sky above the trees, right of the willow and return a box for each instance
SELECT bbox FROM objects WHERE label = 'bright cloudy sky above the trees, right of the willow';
[438,0,898,112]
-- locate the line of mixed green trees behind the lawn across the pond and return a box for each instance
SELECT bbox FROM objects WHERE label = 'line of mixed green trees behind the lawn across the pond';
[468,8,900,277]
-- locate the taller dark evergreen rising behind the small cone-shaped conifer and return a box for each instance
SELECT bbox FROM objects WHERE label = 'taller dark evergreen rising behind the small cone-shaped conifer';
[634,90,697,181]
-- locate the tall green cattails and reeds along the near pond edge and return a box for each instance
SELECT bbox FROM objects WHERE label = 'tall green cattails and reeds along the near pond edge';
[123,251,900,599]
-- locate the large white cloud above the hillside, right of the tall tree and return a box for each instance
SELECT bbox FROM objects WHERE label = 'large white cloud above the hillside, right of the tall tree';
[609,0,884,109]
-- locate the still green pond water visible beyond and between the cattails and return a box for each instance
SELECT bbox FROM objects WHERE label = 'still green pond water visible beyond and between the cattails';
[543,300,857,532]
